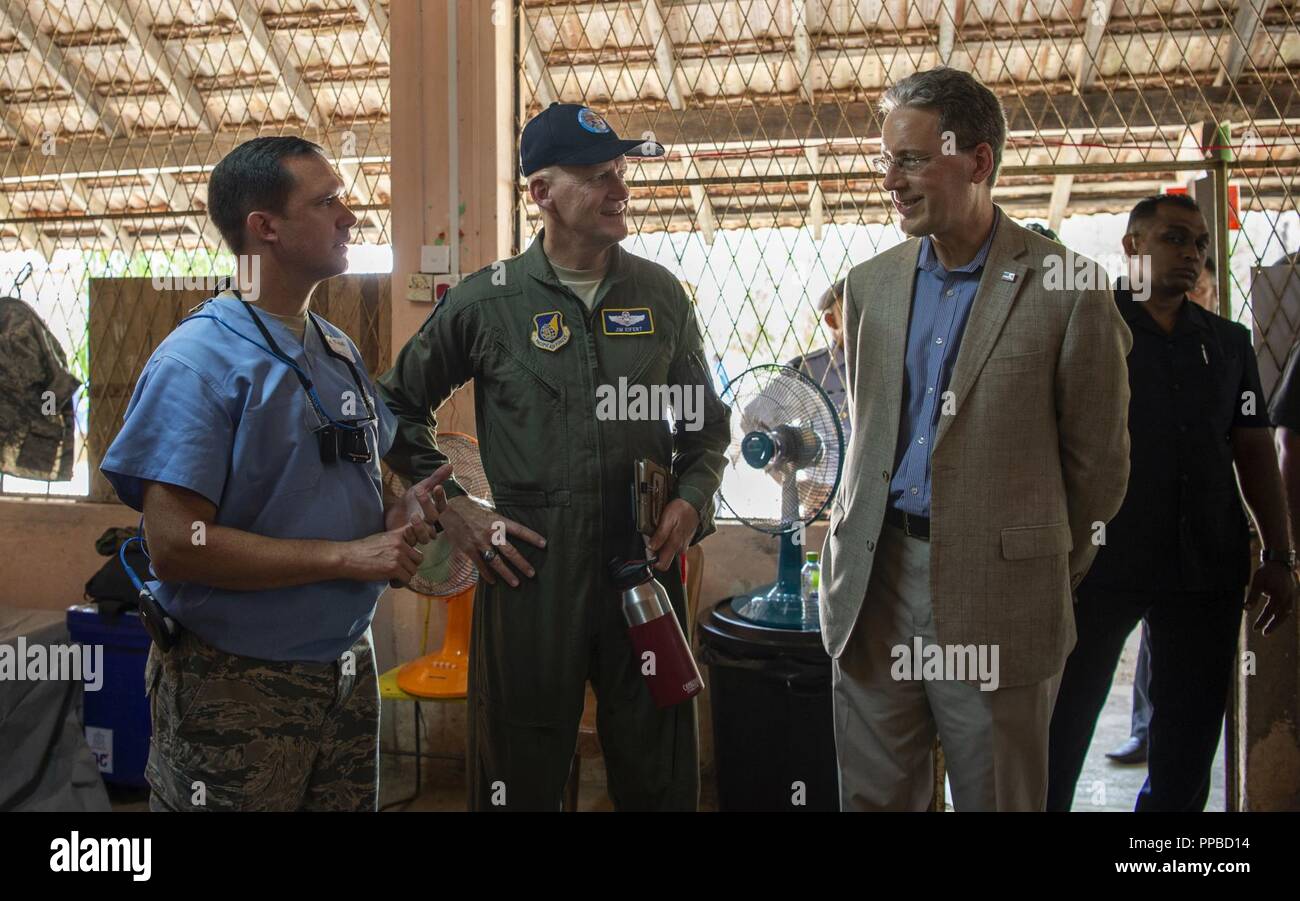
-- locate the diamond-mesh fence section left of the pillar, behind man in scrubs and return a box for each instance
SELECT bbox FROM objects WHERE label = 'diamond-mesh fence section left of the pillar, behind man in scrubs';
[0,0,391,497]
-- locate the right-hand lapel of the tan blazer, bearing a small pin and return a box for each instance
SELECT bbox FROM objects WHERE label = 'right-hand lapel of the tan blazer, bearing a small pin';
[931,213,1028,452]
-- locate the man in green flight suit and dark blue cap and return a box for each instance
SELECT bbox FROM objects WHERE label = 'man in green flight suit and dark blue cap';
[378,104,731,810]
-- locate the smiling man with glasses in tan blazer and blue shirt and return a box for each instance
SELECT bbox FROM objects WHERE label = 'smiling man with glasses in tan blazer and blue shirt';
[822,69,1132,810]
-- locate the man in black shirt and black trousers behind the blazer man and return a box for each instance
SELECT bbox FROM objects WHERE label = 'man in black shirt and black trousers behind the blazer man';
[1048,195,1295,810]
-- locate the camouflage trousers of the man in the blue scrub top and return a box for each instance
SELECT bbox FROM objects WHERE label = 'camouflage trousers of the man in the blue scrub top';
[144,631,380,810]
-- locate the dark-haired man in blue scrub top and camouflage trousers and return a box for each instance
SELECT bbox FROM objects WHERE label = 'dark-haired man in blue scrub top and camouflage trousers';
[101,138,450,810]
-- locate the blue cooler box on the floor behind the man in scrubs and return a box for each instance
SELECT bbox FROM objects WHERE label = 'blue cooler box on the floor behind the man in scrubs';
[68,605,152,788]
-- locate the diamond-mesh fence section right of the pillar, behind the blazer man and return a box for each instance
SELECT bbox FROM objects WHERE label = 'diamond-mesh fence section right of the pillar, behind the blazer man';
[516,0,1300,405]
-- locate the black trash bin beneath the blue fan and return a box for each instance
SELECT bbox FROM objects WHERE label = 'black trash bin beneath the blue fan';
[699,599,840,811]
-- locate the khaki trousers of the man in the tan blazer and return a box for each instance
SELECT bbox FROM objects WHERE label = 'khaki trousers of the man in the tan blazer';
[832,525,1061,810]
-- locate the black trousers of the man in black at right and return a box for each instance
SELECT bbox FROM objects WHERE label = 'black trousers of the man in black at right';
[1048,582,1244,811]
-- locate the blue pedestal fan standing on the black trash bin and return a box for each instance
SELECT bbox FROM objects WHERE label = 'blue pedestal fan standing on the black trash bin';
[720,364,844,632]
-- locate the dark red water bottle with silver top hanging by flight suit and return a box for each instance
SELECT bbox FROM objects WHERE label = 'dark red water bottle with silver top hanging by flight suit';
[610,556,705,709]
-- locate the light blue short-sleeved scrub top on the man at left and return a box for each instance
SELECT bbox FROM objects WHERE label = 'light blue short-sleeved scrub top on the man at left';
[100,295,397,662]
